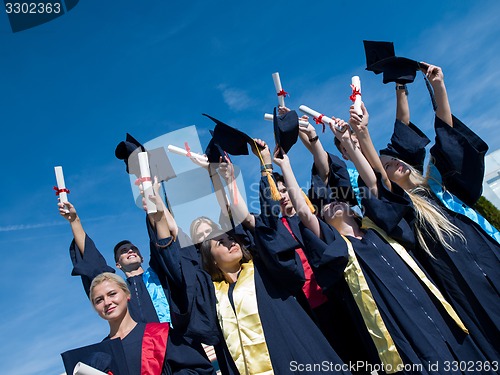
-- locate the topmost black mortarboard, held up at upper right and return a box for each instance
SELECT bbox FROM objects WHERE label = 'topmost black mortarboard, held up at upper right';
[363,40,420,83]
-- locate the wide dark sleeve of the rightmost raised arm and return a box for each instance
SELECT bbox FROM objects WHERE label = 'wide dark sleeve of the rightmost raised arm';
[430,116,488,207]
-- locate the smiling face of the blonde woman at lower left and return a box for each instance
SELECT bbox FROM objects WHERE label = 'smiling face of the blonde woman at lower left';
[91,280,129,321]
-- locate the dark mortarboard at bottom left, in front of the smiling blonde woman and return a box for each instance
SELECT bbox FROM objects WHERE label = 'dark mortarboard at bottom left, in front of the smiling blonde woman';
[61,339,129,375]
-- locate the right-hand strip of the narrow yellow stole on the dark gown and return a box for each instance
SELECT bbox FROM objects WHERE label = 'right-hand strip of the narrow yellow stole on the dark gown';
[362,217,469,334]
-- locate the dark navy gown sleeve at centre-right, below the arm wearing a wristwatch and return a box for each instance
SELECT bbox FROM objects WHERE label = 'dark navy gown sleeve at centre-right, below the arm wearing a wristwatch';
[308,153,358,212]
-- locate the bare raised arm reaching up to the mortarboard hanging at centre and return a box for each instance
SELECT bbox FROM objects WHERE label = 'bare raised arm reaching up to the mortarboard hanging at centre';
[274,148,321,237]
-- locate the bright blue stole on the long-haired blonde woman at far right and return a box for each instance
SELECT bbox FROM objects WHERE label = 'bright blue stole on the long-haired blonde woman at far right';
[427,163,500,243]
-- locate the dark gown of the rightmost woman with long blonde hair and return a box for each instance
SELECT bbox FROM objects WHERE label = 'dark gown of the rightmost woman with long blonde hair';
[378,117,500,360]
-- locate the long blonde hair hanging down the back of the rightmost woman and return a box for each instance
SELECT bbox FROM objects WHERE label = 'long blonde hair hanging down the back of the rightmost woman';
[403,162,466,258]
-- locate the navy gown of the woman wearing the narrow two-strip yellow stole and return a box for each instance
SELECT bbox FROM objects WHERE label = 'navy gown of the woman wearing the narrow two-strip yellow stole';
[303,221,494,374]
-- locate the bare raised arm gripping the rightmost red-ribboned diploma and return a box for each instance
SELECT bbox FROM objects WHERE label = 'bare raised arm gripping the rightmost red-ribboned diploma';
[349,102,392,193]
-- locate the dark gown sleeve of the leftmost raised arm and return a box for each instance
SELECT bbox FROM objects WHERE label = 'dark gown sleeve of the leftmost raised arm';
[69,235,115,296]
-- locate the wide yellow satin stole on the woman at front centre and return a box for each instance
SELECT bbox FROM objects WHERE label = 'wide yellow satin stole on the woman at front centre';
[214,261,274,375]
